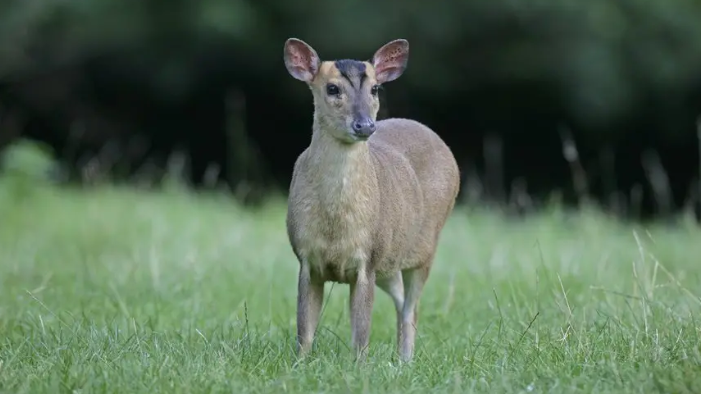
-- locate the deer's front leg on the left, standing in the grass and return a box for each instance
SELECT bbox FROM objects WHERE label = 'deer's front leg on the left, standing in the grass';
[297,261,324,356]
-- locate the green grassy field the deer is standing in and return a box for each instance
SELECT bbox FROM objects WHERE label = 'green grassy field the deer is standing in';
[0,165,701,394]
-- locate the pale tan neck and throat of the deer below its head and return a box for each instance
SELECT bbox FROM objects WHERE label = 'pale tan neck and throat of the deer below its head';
[309,119,375,209]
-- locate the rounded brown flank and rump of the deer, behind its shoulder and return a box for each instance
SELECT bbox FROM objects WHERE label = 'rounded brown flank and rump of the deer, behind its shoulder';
[368,118,460,272]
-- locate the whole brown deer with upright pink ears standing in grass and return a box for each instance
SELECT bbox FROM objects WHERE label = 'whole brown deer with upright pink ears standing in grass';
[284,38,460,361]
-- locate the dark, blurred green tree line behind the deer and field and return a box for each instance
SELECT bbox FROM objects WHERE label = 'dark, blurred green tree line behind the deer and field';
[0,0,701,219]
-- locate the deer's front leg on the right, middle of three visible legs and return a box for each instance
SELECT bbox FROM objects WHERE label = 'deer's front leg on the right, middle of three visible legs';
[350,268,375,360]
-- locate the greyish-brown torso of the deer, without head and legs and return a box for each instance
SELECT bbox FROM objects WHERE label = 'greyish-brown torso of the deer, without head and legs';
[288,119,459,283]
